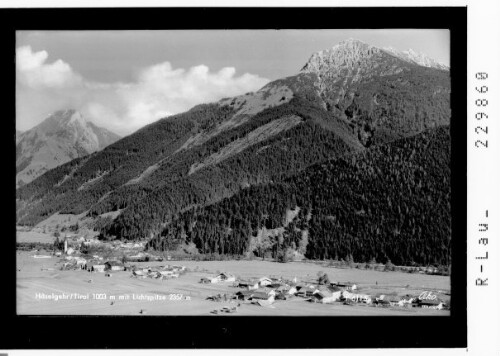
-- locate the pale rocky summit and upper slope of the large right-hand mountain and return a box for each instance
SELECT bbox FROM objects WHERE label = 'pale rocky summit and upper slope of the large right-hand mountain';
[302,39,450,146]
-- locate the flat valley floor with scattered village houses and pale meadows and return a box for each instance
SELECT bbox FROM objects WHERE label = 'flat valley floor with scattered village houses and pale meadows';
[18,231,450,315]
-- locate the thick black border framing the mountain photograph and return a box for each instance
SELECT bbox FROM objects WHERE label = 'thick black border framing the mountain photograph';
[0,7,467,349]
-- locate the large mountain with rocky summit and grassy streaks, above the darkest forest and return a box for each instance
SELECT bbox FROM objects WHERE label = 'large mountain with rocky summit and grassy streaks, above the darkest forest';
[17,40,451,251]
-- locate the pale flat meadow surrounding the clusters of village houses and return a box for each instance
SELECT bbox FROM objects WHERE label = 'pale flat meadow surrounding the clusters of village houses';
[17,251,450,316]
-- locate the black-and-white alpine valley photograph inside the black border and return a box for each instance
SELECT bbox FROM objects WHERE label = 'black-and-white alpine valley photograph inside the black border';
[15,28,454,317]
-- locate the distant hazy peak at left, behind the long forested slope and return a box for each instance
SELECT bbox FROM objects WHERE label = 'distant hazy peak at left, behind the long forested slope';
[16,110,119,185]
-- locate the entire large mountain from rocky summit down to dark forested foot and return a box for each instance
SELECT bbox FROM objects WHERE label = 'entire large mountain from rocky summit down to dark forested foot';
[17,40,451,263]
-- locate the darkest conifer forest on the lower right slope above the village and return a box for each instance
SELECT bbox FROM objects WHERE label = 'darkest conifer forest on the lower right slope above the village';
[149,127,451,265]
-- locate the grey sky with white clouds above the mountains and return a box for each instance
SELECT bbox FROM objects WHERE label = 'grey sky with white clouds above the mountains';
[16,29,449,136]
